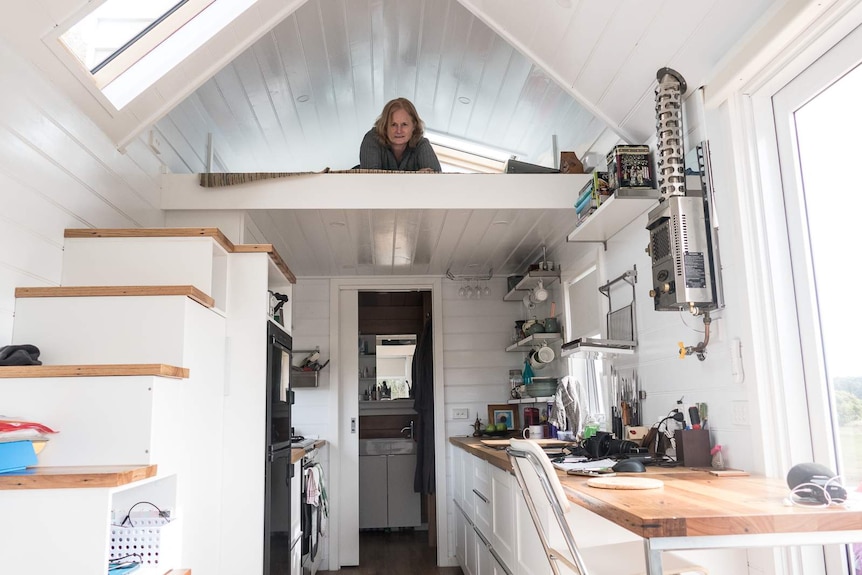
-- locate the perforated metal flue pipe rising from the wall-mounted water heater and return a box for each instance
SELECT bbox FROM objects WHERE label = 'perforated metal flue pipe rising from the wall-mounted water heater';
[655,68,686,200]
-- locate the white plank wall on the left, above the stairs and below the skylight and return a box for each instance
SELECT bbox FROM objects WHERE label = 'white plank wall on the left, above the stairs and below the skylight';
[0,41,164,346]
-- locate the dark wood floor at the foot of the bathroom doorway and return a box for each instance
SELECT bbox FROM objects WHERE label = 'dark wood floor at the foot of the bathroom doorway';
[318,531,462,575]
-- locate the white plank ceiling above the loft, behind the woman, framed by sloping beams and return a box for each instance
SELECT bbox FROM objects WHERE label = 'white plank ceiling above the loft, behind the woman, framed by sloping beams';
[157,0,616,173]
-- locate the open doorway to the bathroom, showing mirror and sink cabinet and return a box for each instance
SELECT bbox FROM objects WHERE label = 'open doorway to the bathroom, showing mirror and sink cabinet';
[358,291,434,530]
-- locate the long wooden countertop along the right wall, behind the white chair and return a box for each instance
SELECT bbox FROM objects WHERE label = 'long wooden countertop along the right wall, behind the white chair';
[449,437,862,538]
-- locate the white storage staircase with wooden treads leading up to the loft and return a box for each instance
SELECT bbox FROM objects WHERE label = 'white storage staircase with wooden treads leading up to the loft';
[0,228,295,575]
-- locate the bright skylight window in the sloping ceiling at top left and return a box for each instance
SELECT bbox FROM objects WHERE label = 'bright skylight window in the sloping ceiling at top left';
[54,0,257,110]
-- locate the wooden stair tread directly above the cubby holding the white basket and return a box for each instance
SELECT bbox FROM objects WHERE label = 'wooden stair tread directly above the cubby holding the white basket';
[0,465,158,489]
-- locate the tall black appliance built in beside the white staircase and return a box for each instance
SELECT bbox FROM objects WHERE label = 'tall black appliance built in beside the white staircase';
[263,321,301,575]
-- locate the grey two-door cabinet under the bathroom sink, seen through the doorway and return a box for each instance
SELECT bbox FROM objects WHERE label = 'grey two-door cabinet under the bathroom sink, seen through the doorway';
[359,453,422,529]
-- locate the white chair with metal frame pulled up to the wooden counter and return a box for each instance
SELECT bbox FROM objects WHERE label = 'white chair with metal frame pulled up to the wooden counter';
[506,439,709,575]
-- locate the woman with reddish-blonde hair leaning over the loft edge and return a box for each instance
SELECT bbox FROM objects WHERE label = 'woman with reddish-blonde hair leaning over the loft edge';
[359,98,442,172]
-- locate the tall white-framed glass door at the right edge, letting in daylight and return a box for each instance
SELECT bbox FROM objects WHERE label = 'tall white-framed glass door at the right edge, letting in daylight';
[773,22,862,575]
